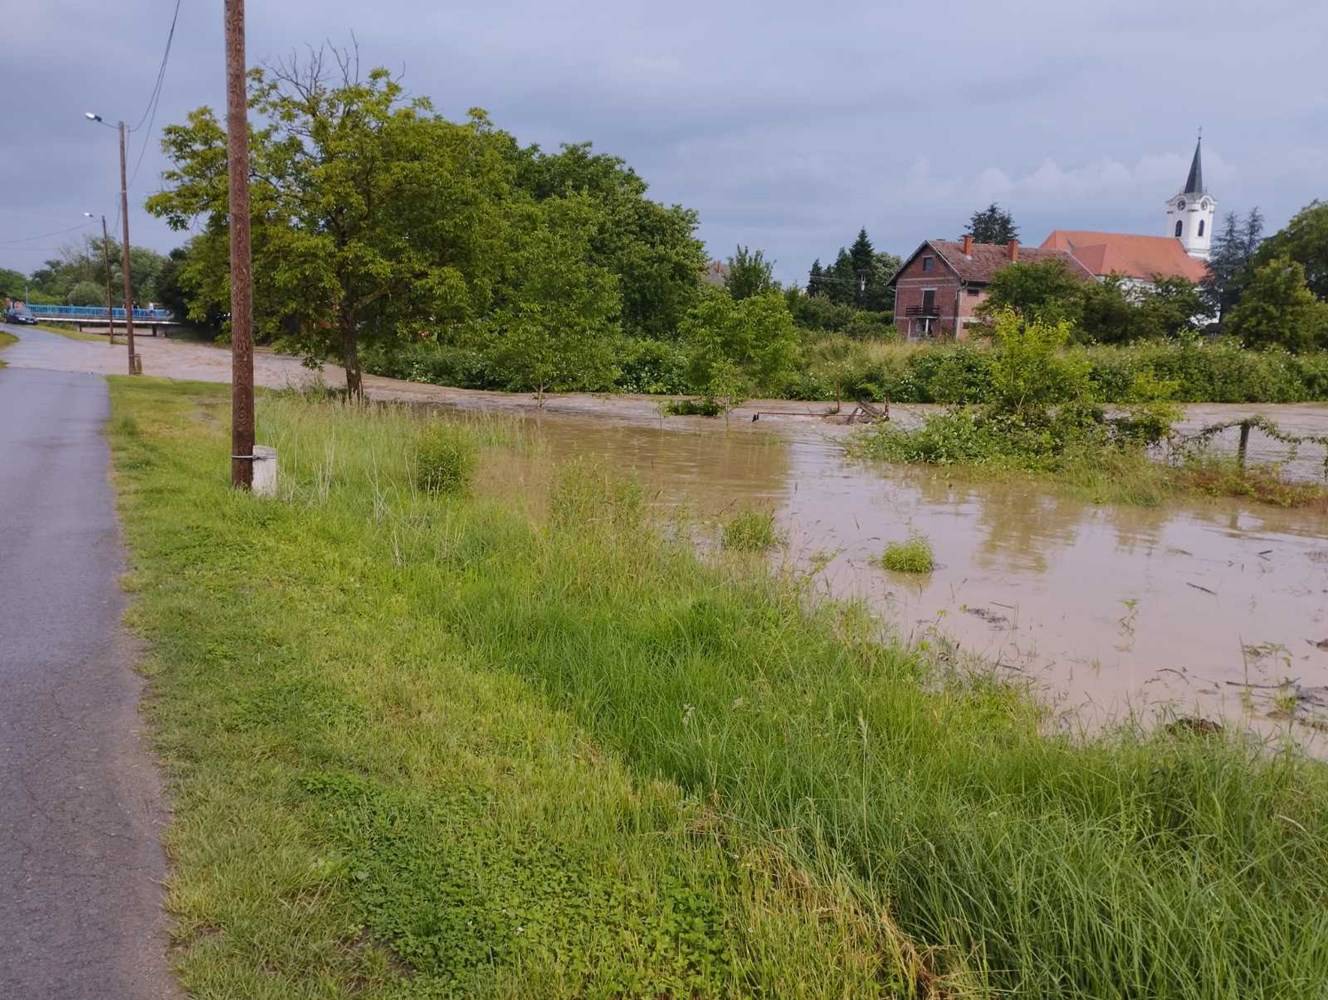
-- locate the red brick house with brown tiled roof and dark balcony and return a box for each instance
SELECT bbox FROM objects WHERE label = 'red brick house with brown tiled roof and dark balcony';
[890,236,1093,340]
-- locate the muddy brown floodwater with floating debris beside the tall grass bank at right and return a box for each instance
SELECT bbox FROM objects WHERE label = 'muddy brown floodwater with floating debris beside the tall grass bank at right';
[499,414,1328,749]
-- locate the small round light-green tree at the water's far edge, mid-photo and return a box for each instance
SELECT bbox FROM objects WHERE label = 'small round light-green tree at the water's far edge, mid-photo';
[683,284,798,405]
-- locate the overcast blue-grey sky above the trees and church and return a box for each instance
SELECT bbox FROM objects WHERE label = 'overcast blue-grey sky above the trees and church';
[0,0,1328,280]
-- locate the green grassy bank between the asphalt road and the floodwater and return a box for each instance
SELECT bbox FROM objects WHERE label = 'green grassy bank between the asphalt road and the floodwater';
[110,378,1328,1000]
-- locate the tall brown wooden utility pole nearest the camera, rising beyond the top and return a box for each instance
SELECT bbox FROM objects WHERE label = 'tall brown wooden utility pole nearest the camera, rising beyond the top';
[226,0,254,490]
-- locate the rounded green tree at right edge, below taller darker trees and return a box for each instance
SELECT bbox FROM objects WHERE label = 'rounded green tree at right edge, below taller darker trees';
[1224,256,1328,351]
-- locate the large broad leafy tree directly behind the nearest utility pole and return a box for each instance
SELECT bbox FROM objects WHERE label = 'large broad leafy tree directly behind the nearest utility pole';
[147,49,511,396]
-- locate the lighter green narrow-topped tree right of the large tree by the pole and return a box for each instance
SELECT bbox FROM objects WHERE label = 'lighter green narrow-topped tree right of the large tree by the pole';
[482,194,622,405]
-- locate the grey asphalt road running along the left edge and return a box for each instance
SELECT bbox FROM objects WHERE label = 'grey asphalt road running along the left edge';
[0,353,177,1000]
